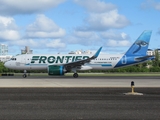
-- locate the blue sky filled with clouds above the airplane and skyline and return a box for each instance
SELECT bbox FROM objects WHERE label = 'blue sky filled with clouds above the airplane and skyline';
[0,0,160,55]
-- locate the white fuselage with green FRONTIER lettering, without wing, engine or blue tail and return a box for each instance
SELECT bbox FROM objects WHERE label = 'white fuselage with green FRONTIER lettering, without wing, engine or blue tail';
[5,54,122,70]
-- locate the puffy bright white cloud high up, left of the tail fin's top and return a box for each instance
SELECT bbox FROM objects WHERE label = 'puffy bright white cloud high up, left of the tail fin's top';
[87,10,130,30]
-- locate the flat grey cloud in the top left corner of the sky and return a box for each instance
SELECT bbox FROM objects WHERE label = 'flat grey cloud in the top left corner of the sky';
[0,0,65,15]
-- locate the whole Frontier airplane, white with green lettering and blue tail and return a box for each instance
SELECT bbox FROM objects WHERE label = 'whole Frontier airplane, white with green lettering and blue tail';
[4,30,154,78]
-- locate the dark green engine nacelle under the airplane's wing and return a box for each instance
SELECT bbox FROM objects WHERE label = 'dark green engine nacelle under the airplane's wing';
[48,65,64,75]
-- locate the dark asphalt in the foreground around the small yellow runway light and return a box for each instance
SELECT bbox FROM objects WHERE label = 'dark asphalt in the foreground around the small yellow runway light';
[0,88,160,120]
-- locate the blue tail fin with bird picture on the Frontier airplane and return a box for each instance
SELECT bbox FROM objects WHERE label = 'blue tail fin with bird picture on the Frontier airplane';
[125,30,152,56]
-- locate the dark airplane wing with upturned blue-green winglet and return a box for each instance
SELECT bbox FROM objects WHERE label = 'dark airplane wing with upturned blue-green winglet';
[64,47,102,70]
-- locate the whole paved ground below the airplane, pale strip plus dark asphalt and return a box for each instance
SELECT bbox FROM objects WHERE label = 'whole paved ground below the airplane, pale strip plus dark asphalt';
[0,76,160,120]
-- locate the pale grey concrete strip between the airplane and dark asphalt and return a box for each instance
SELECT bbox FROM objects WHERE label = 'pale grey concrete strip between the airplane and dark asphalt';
[0,76,160,88]
